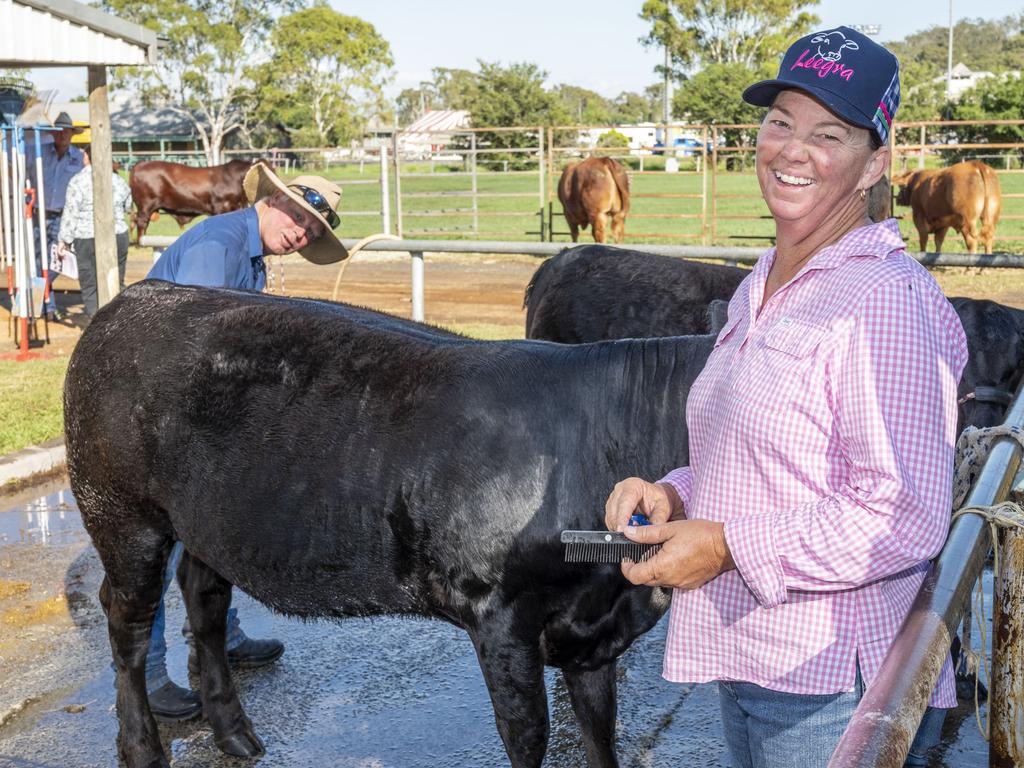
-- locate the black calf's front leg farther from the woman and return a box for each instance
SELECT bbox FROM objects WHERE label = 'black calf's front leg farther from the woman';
[470,616,548,768]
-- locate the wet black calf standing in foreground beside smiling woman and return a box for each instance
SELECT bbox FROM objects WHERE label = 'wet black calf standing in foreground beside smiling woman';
[65,281,714,768]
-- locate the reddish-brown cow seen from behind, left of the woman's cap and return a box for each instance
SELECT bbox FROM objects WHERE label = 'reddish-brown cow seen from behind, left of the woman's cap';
[558,158,630,243]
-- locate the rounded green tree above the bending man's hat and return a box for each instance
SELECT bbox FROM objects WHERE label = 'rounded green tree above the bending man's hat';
[261,4,393,146]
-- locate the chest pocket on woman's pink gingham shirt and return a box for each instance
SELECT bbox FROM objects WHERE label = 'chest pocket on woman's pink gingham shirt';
[732,318,828,412]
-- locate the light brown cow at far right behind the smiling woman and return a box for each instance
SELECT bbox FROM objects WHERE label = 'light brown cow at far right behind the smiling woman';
[893,160,1002,253]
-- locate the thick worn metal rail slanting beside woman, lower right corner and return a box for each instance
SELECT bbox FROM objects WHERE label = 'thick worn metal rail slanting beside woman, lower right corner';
[828,389,1024,768]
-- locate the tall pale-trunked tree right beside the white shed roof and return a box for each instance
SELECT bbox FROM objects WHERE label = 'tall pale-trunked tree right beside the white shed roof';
[102,0,301,165]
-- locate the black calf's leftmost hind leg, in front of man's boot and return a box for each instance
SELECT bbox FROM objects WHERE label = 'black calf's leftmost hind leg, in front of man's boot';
[99,527,170,768]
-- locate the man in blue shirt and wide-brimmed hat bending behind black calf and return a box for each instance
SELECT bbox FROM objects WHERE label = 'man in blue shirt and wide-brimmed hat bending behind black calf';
[145,163,348,722]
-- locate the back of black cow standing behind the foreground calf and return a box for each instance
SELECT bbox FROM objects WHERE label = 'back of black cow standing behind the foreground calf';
[523,246,750,344]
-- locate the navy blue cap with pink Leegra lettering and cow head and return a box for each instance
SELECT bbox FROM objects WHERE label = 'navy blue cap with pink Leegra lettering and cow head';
[743,27,899,143]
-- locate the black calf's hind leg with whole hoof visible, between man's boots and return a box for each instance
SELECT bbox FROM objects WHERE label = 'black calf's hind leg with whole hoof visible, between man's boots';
[178,550,264,758]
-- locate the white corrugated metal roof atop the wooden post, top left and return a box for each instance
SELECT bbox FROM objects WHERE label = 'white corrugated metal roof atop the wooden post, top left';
[0,0,157,67]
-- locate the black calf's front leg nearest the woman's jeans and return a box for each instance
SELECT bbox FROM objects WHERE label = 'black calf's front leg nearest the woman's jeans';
[562,662,618,768]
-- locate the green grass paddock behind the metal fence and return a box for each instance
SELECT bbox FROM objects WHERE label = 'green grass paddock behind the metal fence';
[150,158,1024,253]
